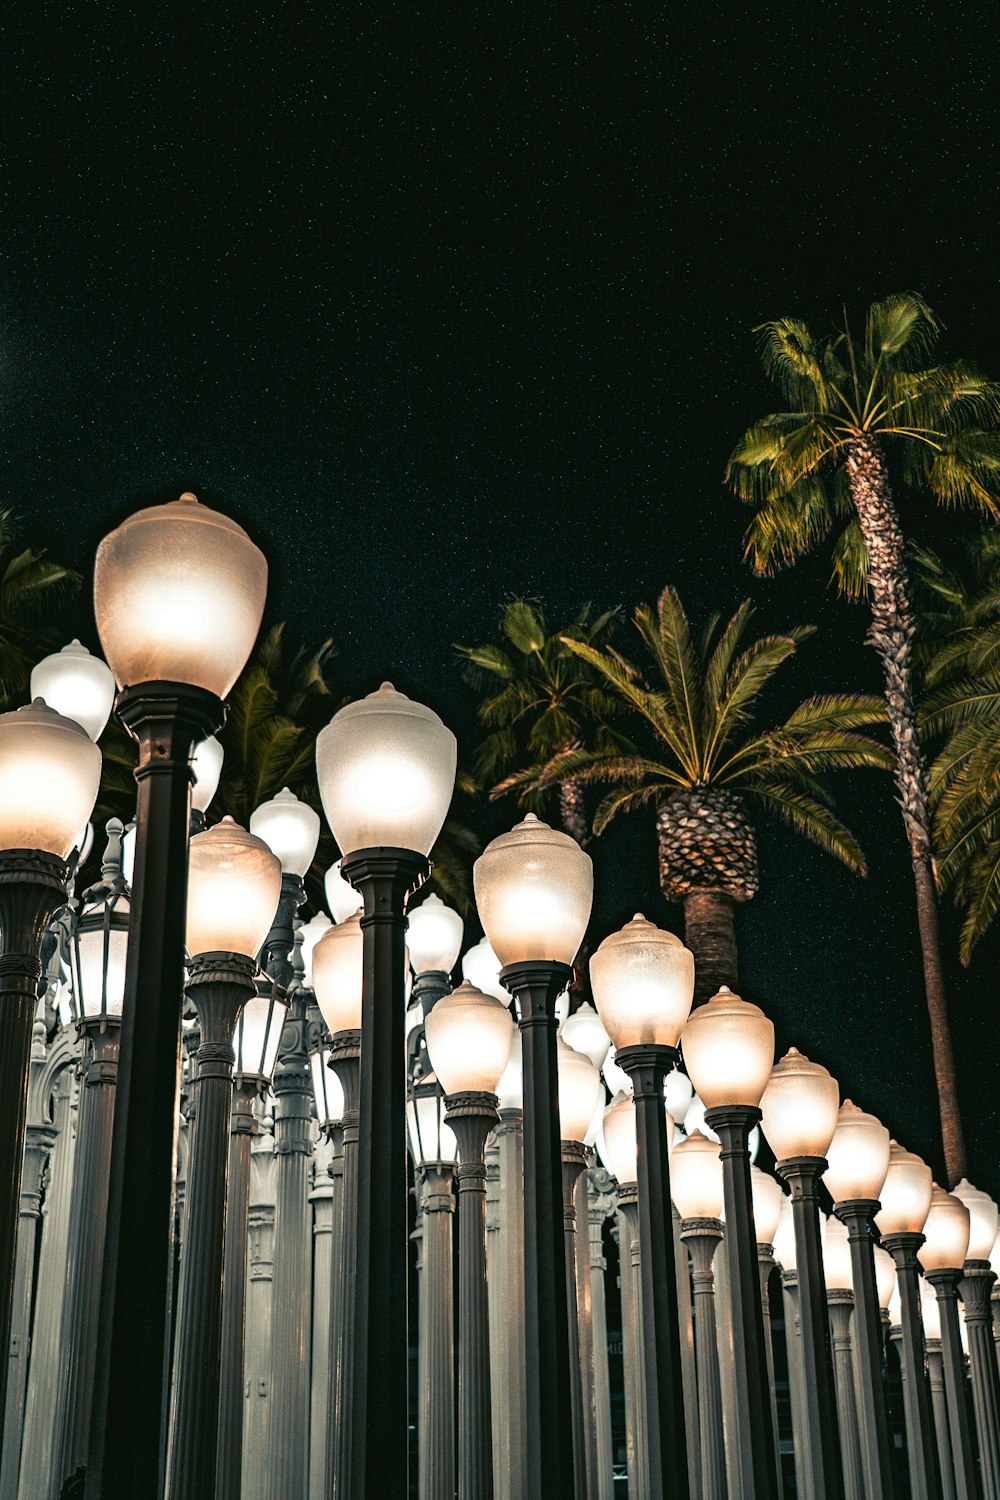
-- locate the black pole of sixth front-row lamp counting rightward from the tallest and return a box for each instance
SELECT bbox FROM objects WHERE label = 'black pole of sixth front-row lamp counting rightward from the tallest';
[773,1152,843,1500]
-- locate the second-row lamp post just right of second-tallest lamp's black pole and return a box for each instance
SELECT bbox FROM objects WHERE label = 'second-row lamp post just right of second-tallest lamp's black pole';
[424,981,514,1500]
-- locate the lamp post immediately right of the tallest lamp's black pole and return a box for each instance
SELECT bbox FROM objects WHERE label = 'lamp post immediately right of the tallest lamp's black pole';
[166,818,280,1500]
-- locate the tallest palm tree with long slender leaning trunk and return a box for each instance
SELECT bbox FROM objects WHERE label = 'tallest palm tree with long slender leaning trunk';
[727,293,1000,1182]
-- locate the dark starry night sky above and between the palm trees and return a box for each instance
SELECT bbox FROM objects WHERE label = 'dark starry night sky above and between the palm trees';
[7,0,1000,1196]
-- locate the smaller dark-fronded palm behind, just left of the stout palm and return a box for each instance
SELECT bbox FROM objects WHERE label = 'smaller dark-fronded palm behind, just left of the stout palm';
[456,599,619,845]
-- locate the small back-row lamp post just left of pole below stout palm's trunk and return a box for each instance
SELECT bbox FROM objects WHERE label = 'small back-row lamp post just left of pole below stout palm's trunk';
[670,1131,727,1500]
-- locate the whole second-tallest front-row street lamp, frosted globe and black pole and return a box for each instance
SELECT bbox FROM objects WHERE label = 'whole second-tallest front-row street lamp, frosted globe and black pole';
[313,683,457,1500]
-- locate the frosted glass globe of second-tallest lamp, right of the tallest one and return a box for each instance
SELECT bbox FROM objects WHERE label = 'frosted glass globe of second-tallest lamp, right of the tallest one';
[316,683,457,857]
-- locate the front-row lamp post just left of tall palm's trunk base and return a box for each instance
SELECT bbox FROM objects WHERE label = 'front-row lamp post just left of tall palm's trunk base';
[876,1142,945,1500]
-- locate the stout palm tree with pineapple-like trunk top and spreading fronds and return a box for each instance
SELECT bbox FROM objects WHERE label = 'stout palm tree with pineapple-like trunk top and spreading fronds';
[538,588,894,1002]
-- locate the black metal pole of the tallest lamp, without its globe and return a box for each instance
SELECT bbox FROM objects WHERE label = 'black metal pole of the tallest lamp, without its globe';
[87,683,225,1500]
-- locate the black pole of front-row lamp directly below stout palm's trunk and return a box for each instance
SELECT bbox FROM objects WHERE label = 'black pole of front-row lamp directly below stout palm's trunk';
[705,1104,779,1500]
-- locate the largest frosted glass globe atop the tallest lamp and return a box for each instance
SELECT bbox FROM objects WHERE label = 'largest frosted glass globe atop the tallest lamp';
[94,495,267,698]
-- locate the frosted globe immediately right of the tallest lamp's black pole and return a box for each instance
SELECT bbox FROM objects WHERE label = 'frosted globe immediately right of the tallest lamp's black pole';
[187,818,282,959]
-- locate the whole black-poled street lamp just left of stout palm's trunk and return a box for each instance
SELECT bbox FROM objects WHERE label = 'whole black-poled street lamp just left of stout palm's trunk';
[591,915,694,1500]
